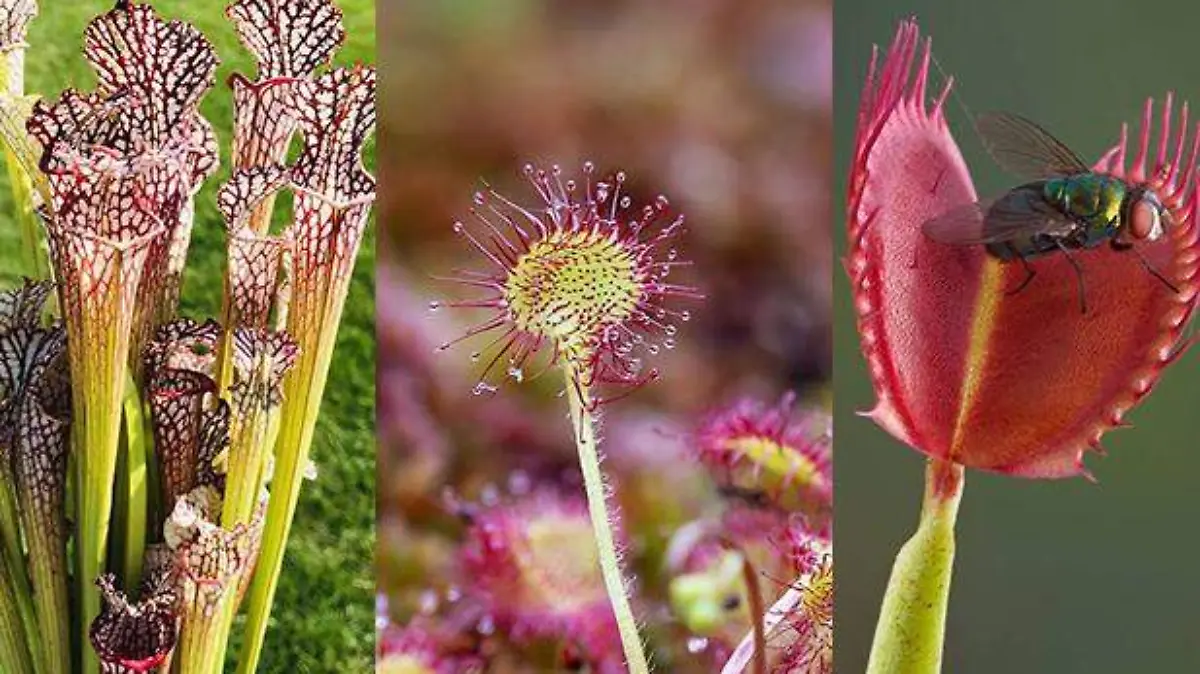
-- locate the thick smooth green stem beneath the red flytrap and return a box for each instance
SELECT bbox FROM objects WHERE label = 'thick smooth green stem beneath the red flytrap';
[866,459,962,674]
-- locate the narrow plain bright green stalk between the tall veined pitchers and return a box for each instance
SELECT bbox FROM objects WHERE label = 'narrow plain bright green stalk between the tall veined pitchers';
[116,377,149,588]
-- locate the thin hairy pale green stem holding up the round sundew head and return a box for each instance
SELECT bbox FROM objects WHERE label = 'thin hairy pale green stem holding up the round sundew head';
[564,365,650,674]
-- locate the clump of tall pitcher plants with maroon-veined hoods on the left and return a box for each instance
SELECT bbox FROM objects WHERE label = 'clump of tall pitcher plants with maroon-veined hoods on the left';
[0,0,376,674]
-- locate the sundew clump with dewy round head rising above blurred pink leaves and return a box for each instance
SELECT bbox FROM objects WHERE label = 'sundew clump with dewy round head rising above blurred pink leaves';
[379,162,833,674]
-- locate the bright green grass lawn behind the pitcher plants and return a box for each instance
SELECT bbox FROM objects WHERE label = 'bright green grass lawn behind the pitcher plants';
[0,0,376,673]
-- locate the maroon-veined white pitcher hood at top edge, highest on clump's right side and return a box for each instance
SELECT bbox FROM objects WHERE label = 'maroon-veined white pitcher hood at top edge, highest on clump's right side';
[226,0,346,79]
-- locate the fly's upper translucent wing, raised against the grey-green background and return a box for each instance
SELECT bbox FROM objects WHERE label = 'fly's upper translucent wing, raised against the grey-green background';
[976,113,1091,179]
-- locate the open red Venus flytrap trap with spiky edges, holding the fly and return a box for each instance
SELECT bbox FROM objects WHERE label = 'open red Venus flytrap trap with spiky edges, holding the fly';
[846,23,1200,477]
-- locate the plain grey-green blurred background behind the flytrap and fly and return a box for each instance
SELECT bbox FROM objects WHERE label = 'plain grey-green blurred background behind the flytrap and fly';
[834,0,1200,674]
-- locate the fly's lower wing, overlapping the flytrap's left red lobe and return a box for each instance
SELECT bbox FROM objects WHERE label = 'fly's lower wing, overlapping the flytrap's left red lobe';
[922,183,1076,246]
